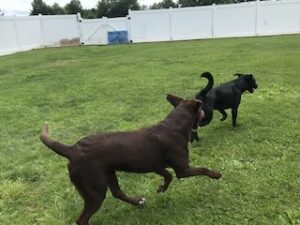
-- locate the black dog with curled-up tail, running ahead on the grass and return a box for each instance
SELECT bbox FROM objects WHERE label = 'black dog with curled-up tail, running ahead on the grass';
[191,72,258,142]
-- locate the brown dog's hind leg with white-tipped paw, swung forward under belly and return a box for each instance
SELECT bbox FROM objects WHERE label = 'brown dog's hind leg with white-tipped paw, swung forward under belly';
[107,171,146,206]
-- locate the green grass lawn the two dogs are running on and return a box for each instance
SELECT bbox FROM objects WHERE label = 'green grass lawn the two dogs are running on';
[0,35,300,225]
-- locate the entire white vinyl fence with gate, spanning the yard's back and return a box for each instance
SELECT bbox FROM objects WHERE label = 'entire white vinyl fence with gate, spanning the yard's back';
[0,0,300,55]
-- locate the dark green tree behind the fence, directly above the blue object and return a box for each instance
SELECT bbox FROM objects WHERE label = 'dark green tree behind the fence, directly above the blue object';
[97,0,140,18]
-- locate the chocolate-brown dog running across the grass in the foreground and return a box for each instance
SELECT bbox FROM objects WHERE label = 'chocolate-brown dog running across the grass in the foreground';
[40,95,221,225]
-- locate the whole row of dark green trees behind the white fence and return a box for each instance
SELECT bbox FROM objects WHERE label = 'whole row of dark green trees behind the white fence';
[30,0,255,19]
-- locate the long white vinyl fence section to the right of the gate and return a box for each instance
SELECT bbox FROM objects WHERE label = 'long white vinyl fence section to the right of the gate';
[129,0,300,42]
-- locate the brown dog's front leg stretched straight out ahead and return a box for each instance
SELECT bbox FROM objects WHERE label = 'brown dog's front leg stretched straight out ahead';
[175,167,222,179]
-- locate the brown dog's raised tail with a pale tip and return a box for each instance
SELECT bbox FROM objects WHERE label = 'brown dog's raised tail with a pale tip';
[40,122,74,160]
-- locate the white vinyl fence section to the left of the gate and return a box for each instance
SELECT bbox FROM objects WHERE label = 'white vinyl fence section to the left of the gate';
[0,15,79,55]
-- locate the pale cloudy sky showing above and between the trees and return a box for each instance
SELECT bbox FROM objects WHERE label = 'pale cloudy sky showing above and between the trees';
[0,0,160,16]
